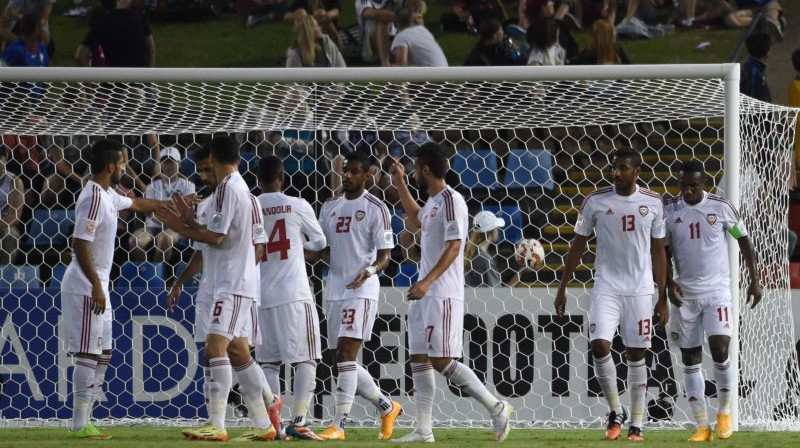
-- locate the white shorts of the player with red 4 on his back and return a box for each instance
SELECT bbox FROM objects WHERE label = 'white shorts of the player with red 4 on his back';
[256,302,322,364]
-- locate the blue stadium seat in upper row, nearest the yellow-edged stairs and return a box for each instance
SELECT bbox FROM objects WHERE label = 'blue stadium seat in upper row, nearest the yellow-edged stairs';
[503,149,555,190]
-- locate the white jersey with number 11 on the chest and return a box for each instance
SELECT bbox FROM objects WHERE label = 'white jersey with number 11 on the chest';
[664,192,747,297]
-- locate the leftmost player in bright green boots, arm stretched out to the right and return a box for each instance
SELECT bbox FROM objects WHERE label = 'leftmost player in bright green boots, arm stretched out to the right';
[61,139,175,439]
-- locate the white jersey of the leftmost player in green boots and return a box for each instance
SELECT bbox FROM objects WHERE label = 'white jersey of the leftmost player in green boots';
[61,180,133,295]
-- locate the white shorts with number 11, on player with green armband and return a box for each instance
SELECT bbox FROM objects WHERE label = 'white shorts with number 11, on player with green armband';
[669,293,733,348]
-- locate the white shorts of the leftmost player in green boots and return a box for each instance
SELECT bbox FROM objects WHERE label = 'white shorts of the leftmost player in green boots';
[61,291,114,355]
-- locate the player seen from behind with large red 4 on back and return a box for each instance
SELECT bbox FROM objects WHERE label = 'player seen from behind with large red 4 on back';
[256,156,327,440]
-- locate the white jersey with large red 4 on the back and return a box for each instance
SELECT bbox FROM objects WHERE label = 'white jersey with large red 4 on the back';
[258,193,325,308]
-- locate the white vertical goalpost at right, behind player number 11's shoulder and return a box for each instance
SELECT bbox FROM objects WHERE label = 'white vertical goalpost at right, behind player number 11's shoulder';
[724,64,741,431]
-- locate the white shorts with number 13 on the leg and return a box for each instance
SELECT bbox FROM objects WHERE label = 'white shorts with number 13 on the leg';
[589,293,653,348]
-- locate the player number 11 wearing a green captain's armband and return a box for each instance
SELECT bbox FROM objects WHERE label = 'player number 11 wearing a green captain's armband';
[664,160,761,442]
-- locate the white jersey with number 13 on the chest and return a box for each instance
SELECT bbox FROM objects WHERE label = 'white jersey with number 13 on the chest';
[575,186,665,296]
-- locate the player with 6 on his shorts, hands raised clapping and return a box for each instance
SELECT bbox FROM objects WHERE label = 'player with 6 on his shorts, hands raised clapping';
[156,137,280,441]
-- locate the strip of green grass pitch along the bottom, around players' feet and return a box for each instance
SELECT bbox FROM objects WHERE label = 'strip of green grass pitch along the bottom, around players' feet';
[0,427,800,448]
